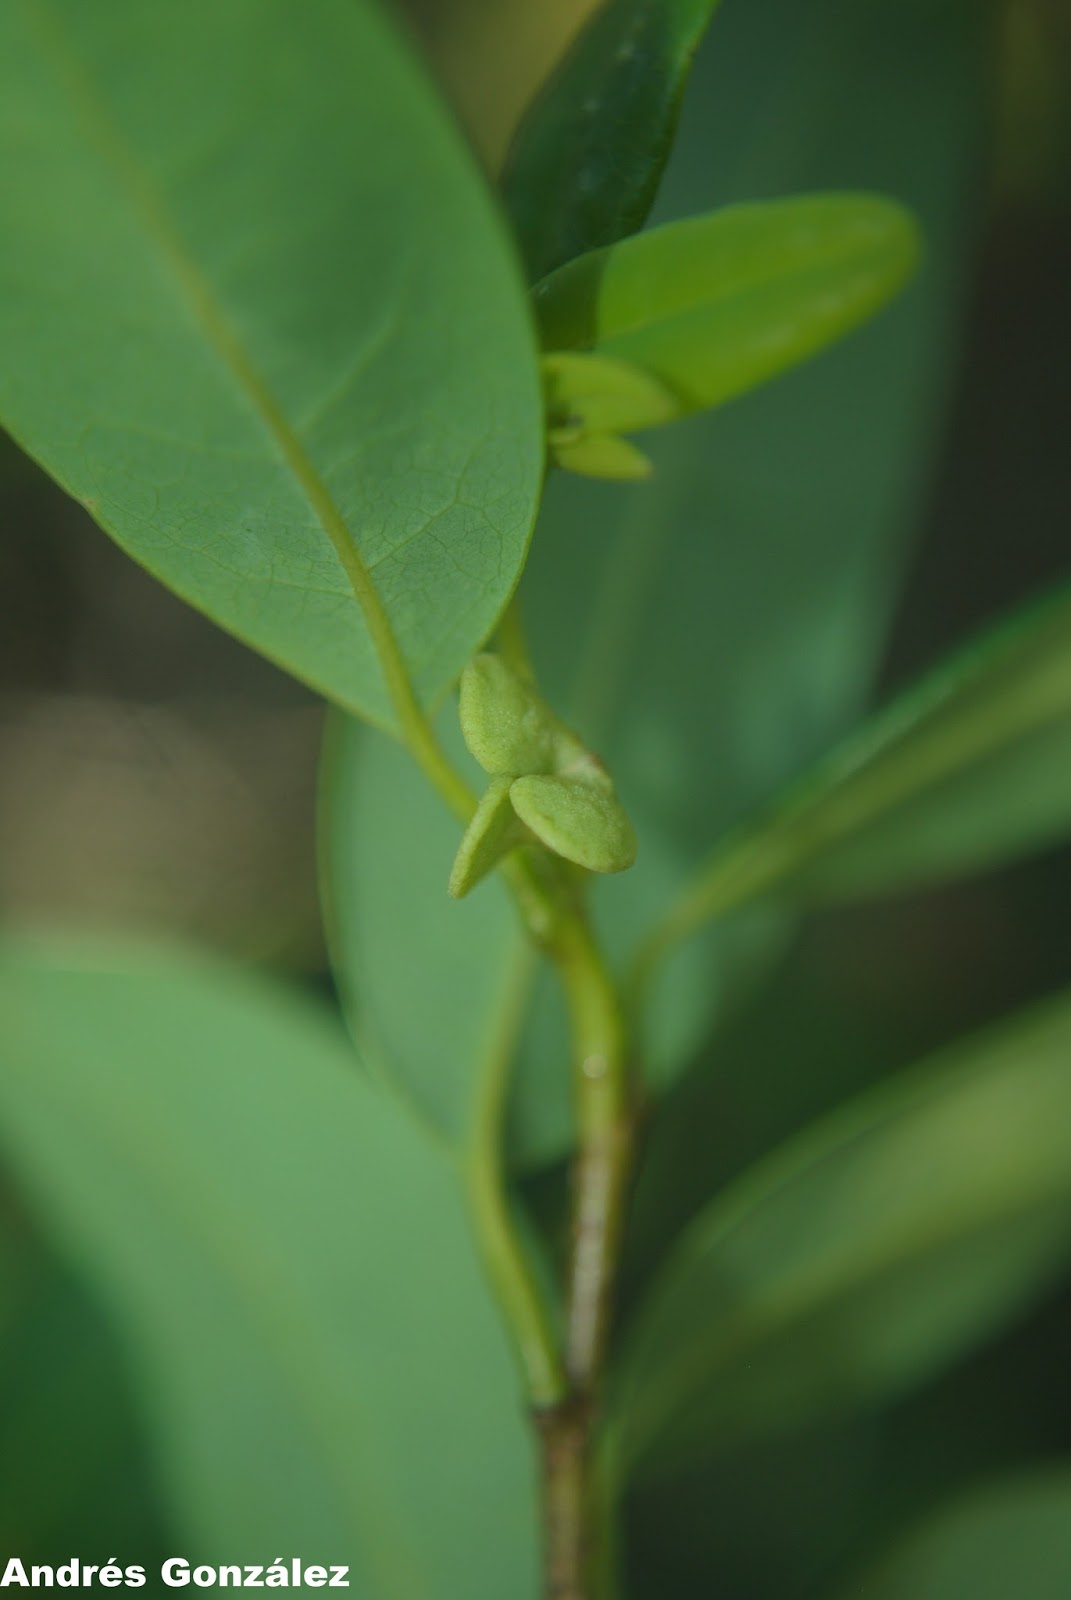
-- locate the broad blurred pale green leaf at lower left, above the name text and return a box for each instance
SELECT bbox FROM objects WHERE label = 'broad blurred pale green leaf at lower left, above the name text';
[0,946,536,1600]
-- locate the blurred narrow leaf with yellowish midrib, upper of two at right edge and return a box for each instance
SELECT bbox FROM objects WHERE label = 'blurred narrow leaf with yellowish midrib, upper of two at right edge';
[650,592,1071,957]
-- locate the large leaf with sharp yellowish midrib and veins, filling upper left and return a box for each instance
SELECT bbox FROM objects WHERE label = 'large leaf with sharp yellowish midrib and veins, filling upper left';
[0,0,543,725]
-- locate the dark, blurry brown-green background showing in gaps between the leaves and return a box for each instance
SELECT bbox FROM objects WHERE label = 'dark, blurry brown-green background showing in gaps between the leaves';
[0,0,1071,1600]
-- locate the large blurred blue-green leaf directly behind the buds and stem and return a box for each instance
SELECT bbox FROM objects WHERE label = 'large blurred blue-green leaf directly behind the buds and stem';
[323,0,985,1160]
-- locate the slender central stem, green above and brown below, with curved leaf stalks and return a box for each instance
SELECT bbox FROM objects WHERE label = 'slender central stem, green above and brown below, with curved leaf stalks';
[394,659,634,1600]
